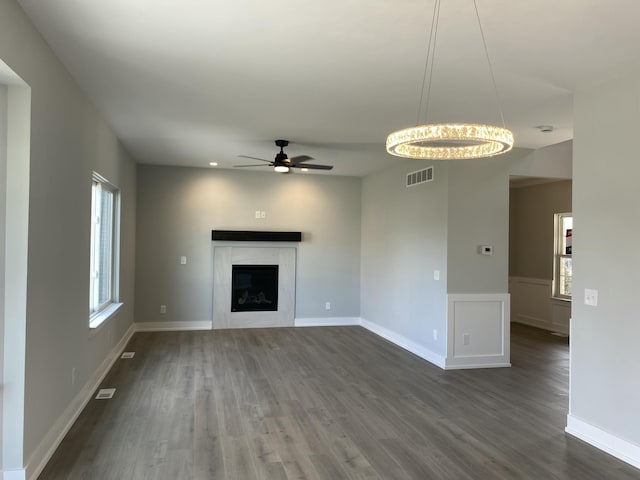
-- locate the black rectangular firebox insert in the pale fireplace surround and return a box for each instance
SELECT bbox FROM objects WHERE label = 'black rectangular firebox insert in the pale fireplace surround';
[231,265,278,312]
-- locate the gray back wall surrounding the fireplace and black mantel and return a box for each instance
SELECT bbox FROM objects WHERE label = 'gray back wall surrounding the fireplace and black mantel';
[136,165,361,322]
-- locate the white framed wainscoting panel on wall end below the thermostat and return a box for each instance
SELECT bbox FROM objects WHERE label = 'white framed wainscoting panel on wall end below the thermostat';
[445,293,511,370]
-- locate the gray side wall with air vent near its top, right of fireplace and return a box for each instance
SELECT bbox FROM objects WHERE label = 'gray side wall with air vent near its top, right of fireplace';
[361,161,448,356]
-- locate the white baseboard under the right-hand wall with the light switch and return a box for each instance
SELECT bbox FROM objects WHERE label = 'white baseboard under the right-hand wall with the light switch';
[564,415,640,468]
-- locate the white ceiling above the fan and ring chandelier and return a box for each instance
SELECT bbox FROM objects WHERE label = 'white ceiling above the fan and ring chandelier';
[18,0,640,175]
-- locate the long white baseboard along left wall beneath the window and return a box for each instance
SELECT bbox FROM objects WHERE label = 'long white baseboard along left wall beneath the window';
[24,325,135,480]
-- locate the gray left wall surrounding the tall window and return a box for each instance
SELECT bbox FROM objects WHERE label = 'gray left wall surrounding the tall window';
[0,0,136,467]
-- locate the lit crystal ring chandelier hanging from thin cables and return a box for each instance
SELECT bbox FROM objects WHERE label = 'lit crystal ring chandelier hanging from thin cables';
[386,0,513,160]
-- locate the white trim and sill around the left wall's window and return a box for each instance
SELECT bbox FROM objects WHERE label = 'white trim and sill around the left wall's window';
[89,172,124,329]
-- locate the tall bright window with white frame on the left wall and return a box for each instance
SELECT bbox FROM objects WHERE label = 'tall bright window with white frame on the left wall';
[89,173,122,328]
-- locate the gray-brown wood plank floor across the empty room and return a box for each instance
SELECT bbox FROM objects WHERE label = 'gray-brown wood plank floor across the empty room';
[39,325,640,480]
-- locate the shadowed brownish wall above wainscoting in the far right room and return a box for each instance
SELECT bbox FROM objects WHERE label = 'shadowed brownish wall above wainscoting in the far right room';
[509,180,571,280]
